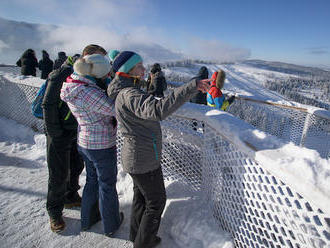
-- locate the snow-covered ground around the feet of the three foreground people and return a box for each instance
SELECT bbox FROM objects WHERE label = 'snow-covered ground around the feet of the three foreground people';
[0,117,233,248]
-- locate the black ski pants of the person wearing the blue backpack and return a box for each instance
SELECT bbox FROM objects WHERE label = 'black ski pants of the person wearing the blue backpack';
[46,130,84,218]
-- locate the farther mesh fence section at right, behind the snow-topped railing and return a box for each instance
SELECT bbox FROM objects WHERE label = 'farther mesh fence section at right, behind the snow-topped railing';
[228,99,330,159]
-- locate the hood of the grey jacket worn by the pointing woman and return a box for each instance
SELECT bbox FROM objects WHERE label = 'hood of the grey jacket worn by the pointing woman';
[107,72,140,101]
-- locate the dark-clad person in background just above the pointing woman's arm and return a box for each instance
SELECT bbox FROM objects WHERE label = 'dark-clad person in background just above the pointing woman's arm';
[147,63,167,97]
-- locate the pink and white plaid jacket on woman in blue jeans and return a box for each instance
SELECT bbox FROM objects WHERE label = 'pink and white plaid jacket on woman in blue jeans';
[60,74,117,150]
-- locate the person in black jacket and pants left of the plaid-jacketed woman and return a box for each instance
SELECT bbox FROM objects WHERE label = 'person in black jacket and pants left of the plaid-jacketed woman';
[42,45,107,232]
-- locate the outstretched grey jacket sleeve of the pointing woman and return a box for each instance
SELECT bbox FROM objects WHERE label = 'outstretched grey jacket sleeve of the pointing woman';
[120,79,197,121]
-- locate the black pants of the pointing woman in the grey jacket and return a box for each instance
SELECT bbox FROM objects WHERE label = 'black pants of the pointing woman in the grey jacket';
[130,168,166,248]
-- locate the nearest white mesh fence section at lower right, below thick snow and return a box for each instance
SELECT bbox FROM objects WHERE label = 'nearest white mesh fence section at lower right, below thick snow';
[203,123,330,248]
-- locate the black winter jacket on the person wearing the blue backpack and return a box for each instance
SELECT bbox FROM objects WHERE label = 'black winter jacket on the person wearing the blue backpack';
[42,60,78,138]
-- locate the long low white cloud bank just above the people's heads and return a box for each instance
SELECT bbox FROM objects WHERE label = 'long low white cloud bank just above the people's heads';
[36,26,250,62]
